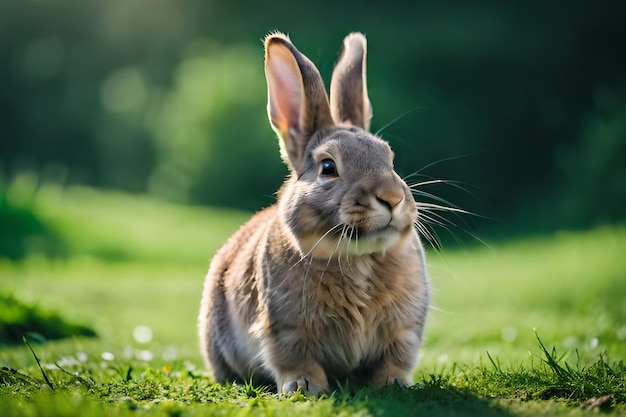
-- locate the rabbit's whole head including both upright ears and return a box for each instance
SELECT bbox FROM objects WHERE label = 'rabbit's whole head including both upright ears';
[265,33,417,258]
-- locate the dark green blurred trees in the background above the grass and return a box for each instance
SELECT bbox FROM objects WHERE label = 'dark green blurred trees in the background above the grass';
[0,0,626,236]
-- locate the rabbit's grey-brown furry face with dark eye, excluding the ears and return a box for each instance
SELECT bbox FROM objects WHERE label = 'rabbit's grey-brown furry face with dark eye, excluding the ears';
[281,127,417,258]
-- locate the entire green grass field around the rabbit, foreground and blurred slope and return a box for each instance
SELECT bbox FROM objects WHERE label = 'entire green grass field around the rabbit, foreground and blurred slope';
[0,186,626,416]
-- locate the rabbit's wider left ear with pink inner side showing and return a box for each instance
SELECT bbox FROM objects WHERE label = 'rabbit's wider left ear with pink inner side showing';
[265,33,333,172]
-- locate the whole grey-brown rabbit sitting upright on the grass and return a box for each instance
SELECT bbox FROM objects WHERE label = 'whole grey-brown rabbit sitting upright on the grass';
[198,33,430,395]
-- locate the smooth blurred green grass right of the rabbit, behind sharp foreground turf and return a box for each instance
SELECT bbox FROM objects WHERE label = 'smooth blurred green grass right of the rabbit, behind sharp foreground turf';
[424,224,626,368]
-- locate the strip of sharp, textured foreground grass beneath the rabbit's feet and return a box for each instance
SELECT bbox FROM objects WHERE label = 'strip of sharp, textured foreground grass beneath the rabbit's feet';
[0,341,626,416]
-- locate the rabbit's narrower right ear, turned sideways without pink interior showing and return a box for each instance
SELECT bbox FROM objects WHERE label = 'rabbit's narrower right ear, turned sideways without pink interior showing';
[330,33,372,130]
